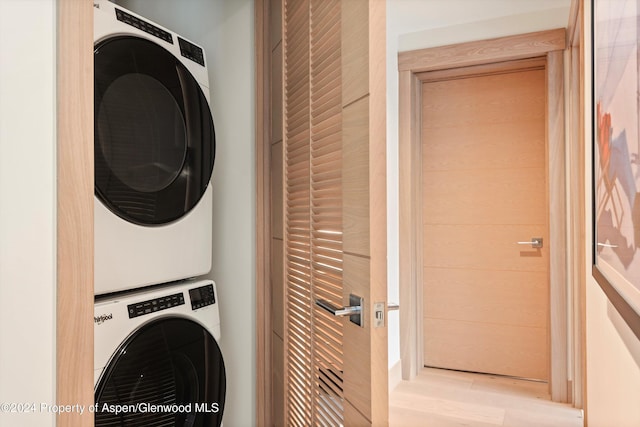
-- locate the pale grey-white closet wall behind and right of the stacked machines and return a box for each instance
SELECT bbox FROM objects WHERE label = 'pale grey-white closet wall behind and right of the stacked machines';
[116,0,256,427]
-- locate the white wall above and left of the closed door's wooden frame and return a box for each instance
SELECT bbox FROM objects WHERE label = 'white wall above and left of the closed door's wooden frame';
[387,0,570,383]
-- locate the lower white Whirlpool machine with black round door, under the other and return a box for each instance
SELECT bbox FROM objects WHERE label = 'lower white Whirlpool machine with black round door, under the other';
[94,280,226,427]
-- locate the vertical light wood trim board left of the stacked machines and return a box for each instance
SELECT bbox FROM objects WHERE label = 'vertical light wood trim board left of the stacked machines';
[56,0,94,427]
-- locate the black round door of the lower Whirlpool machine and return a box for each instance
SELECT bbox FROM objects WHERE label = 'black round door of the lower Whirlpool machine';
[95,317,226,427]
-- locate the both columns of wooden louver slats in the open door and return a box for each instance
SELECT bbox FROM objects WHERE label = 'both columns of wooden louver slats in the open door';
[285,1,343,424]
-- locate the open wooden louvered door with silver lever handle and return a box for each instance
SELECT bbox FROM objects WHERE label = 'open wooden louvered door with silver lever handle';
[283,0,388,426]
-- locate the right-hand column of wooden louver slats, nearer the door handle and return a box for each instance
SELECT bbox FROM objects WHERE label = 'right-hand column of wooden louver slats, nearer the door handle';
[309,0,344,425]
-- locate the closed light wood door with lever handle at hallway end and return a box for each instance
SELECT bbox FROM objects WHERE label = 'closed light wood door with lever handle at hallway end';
[422,66,549,380]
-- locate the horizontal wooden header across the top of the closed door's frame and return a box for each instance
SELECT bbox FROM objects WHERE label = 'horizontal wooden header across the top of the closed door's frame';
[398,28,566,73]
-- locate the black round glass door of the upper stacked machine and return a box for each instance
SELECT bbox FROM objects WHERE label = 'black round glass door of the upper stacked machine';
[94,36,215,225]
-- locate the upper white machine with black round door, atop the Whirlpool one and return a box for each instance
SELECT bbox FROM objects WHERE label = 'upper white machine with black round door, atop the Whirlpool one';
[94,0,215,295]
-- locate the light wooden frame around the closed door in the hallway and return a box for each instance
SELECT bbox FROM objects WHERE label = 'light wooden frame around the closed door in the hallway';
[398,28,569,402]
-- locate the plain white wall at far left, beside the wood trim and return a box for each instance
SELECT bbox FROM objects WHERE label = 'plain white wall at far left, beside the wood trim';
[0,0,56,427]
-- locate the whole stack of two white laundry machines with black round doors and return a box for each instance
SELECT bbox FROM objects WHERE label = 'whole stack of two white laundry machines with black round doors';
[94,0,226,426]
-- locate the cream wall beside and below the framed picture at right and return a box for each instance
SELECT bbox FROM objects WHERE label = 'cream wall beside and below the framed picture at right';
[583,3,640,427]
